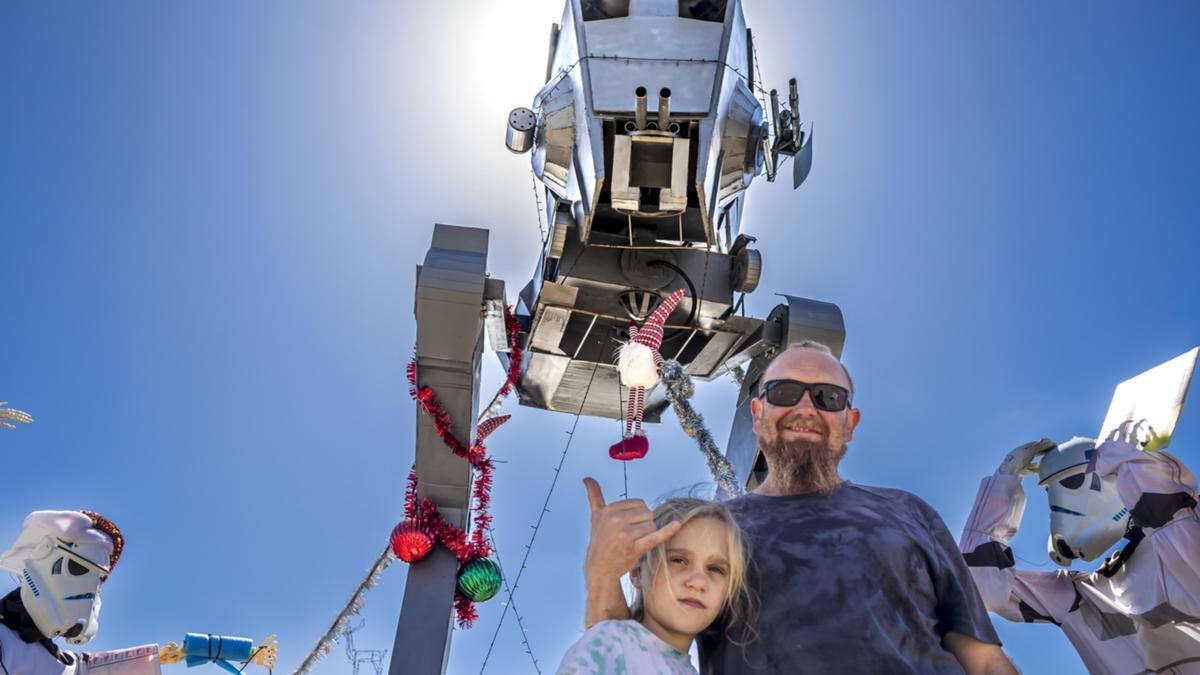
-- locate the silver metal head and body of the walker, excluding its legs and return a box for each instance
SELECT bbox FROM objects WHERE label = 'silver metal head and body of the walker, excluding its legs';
[518,0,840,419]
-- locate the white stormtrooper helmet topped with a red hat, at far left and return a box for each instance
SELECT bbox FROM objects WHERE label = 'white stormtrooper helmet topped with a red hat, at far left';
[0,510,125,645]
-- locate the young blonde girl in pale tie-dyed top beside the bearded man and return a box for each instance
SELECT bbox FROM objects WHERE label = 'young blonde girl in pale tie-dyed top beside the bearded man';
[558,497,749,675]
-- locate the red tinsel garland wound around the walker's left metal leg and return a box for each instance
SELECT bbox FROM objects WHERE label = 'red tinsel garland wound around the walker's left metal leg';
[404,306,522,628]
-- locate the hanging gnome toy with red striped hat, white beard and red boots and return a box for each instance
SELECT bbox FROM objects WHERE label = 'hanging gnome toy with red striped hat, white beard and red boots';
[608,288,683,461]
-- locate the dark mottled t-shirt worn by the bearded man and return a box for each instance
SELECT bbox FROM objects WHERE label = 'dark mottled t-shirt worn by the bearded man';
[698,483,1000,674]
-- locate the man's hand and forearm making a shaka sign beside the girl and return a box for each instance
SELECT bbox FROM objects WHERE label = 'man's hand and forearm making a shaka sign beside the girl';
[583,478,680,628]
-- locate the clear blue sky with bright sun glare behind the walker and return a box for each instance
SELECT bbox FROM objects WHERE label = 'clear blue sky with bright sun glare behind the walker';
[0,0,1200,673]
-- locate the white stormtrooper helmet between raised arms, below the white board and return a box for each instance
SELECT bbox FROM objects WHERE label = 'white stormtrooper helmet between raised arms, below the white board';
[1038,436,1129,567]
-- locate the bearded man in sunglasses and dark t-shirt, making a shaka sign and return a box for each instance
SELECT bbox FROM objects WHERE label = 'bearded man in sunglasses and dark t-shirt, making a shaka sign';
[584,342,1016,674]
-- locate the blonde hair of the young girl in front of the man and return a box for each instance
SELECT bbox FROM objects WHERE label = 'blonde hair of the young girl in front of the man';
[632,497,755,631]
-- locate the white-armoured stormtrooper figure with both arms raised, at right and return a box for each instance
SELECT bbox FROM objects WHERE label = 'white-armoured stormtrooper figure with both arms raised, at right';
[959,438,1200,675]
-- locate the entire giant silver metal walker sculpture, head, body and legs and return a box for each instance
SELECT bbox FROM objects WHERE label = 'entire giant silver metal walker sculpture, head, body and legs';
[390,0,845,674]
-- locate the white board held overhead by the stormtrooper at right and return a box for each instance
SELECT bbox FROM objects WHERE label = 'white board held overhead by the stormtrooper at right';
[1097,347,1200,450]
